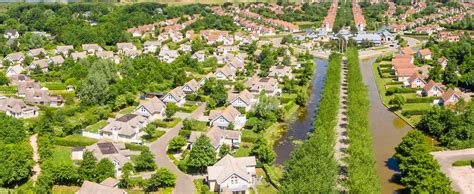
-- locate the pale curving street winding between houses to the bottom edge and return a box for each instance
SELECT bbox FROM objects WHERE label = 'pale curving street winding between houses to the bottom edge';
[150,103,206,194]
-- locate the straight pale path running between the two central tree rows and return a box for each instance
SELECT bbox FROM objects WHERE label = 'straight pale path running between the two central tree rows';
[334,58,349,193]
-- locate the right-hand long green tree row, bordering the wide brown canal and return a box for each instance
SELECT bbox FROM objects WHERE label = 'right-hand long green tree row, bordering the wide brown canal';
[346,48,380,193]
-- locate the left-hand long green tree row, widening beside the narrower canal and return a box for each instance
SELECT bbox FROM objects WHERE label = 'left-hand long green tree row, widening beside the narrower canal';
[280,53,341,193]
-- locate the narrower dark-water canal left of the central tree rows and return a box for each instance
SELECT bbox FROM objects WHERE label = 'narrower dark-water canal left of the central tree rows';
[274,58,328,164]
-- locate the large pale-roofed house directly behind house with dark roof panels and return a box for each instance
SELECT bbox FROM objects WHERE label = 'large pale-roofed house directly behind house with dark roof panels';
[100,114,148,143]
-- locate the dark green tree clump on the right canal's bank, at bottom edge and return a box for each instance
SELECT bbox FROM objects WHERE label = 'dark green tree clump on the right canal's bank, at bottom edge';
[394,130,454,193]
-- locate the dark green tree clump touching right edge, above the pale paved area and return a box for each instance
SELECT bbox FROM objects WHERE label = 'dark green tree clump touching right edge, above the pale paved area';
[417,101,474,149]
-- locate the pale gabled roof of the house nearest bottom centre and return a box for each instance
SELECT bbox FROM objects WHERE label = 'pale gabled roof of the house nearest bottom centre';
[207,155,257,184]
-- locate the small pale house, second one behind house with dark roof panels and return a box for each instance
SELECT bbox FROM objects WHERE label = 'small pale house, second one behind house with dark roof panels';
[134,96,166,121]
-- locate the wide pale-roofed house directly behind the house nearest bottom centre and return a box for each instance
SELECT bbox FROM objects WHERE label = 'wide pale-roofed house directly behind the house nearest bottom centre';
[188,127,242,151]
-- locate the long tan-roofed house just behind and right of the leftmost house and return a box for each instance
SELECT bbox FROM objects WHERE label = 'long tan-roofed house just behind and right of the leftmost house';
[25,89,64,107]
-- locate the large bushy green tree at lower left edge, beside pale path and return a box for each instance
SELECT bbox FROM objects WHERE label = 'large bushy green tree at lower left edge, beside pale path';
[0,142,34,187]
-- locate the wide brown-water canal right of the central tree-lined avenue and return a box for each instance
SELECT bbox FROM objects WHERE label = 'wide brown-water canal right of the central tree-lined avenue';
[360,58,412,193]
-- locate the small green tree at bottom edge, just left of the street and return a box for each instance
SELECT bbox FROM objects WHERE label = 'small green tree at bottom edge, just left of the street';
[146,168,176,192]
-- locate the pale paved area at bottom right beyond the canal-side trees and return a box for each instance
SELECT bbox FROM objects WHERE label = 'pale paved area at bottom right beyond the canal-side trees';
[431,148,474,194]
